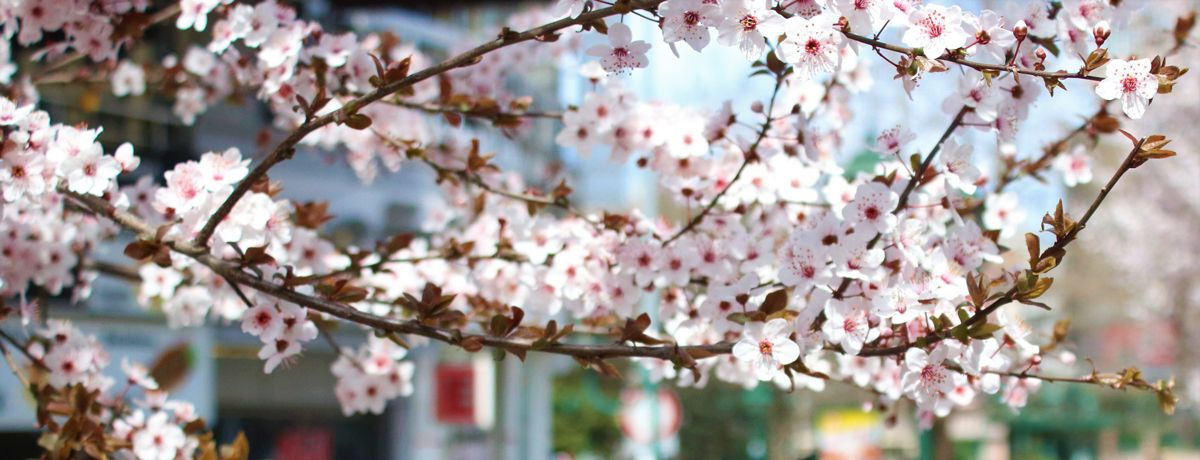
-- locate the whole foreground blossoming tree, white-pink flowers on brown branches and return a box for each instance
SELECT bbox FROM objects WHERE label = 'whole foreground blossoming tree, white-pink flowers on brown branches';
[0,0,1195,459]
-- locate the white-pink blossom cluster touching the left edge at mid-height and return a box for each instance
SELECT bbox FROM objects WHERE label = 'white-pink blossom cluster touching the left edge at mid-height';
[0,97,130,314]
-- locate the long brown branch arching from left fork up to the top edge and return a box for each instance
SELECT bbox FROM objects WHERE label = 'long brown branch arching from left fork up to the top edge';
[192,0,664,247]
